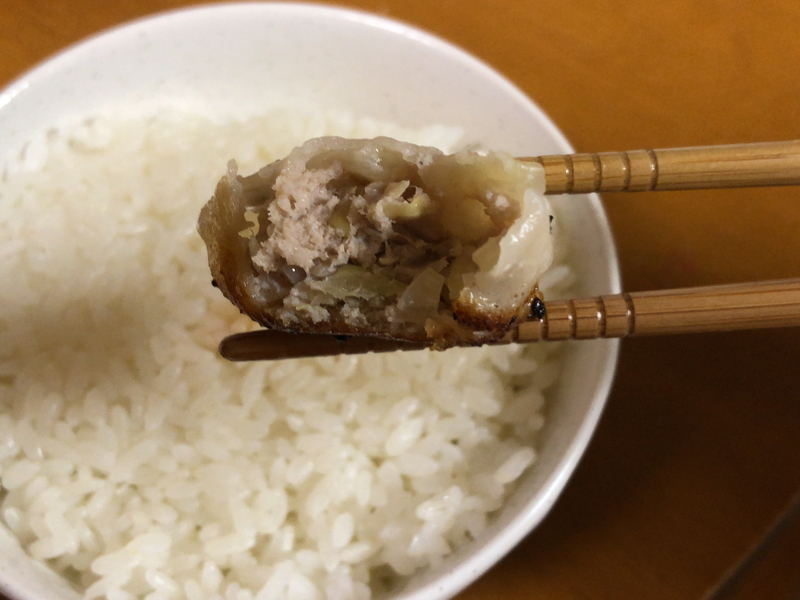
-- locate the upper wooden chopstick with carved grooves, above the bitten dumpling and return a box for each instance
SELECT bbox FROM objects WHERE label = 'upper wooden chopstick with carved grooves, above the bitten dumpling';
[520,140,800,194]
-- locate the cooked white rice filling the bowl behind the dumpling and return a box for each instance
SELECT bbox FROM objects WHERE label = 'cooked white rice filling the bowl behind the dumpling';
[0,112,570,600]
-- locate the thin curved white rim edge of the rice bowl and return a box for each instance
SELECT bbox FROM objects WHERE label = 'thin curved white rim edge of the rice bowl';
[0,1,621,600]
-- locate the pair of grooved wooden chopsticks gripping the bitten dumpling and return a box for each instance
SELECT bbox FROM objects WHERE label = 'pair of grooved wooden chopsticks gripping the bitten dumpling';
[219,140,800,361]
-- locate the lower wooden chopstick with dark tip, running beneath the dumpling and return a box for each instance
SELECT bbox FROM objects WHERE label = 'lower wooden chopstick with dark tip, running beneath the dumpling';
[219,279,800,361]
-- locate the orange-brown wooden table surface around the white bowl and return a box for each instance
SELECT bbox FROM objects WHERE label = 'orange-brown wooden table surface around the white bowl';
[0,0,800,600]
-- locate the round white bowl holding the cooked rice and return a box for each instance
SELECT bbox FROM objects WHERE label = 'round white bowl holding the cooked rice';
[0,3,619,600]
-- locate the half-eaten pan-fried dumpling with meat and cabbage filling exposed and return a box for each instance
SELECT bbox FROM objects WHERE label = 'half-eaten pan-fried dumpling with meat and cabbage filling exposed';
[198,137,553,348]
